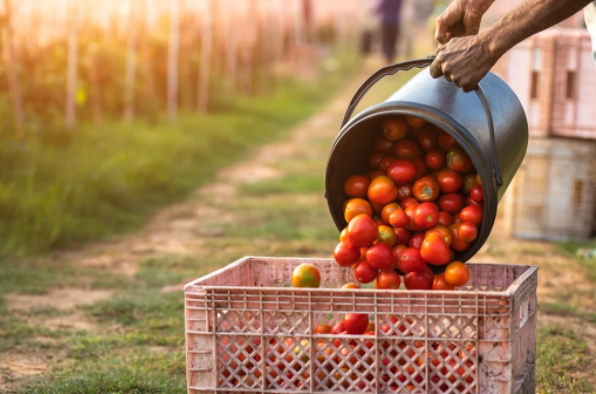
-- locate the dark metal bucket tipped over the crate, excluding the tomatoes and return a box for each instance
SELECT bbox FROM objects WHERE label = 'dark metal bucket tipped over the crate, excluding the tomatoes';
[325,58,528,273]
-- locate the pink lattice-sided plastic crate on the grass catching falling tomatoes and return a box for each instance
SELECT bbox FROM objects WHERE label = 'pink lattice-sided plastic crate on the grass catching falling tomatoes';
[185,257,537,394]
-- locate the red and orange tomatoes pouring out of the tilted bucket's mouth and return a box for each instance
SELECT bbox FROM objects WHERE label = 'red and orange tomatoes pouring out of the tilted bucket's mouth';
[334,116,484,290]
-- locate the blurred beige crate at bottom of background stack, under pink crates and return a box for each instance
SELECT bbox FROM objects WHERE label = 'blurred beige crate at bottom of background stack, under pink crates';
[504,138,596,241]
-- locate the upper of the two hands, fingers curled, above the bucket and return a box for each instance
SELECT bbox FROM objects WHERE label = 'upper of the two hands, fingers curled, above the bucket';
[435,0,494,44]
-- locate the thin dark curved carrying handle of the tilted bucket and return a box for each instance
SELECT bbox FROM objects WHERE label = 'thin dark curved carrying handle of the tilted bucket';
[341,57,503,186]
